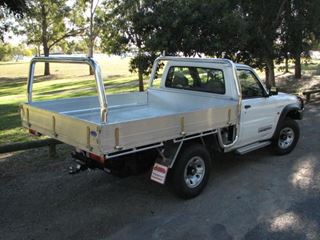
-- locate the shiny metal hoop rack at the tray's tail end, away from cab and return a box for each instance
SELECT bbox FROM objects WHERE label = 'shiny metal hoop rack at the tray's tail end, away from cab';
[27,56,108,123]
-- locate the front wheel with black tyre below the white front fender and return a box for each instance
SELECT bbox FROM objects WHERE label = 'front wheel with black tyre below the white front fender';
[272,118,300,155]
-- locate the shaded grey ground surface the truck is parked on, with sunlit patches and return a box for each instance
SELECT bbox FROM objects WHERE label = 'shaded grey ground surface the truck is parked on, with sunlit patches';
[0,103,320,240]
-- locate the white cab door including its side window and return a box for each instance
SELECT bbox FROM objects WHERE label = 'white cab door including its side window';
[237,69,277,147]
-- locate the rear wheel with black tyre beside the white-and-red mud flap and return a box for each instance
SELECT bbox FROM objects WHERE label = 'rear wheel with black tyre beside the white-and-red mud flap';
[169,144,210,199]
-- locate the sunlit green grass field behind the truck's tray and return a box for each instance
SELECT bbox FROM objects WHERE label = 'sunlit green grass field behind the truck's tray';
[0,57,138,144]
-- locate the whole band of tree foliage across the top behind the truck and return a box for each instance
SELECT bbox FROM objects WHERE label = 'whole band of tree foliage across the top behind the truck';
[1,0,320,84]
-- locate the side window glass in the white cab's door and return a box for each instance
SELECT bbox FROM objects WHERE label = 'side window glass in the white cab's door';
[237,69,264,99]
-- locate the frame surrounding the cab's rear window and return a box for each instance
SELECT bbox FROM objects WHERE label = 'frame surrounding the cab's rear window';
[164,65,227,96]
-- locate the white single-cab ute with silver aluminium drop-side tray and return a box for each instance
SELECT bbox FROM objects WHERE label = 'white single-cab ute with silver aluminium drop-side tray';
[21,57,303,198]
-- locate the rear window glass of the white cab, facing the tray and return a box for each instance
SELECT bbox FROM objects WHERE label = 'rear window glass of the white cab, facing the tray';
[165,66,225,94]
